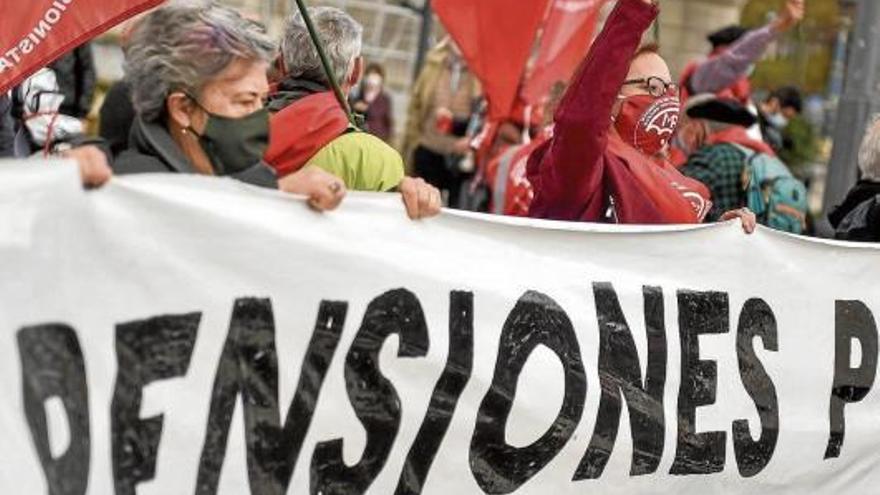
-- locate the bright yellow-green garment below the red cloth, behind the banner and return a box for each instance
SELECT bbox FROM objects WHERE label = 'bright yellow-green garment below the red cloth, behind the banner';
[307,131,404,192]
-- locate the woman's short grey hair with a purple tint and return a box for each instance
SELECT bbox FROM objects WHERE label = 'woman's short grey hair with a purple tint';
[125,1,277,122]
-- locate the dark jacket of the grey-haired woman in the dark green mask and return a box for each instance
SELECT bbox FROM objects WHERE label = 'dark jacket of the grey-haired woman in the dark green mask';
[113,118,278,189]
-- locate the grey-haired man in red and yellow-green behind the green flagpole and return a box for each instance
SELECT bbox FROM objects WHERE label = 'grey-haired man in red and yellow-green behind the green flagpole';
[266,7,428,202]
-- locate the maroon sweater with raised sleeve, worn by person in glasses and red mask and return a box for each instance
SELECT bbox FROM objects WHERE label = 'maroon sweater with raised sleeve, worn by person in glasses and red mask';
[529,0,659,220]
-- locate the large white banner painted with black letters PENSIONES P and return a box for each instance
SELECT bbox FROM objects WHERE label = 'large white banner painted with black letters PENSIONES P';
[0,164,880,495]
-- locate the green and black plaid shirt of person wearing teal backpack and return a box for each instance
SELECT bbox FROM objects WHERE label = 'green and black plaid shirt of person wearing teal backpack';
[681,144,746,222]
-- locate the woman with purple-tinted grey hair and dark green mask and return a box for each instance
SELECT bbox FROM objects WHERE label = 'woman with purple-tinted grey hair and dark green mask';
[113,3,345,210]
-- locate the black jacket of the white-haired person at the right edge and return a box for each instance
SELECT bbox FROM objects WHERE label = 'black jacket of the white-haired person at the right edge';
[828,180,880,242]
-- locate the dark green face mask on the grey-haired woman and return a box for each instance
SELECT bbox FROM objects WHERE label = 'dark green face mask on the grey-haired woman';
[190,98,269,175]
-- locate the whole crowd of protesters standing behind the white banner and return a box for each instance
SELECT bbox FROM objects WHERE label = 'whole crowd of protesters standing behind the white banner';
[0,0,880,241]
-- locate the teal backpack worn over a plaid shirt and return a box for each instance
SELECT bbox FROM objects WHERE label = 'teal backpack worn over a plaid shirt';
[737,145,808,234]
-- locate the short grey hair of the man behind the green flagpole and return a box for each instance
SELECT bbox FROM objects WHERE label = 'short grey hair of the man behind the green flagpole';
[281,7,364,86]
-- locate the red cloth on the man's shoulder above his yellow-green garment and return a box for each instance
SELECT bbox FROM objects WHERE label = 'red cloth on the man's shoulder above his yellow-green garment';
[265,91,348,177]
